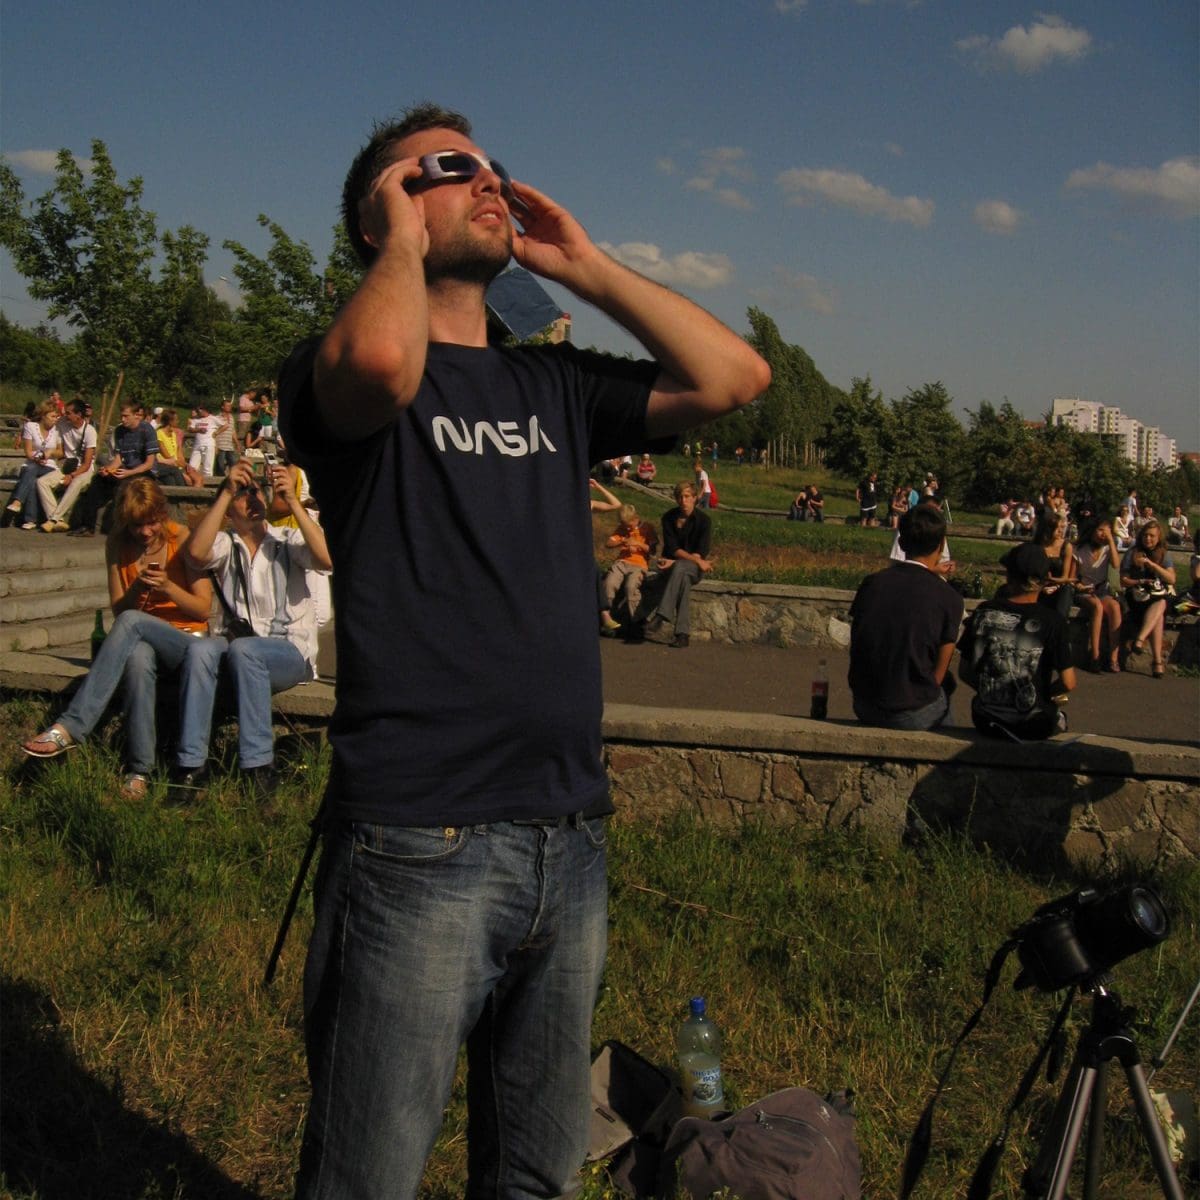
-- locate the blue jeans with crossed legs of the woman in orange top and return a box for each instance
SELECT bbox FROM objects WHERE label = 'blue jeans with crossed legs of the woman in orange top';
[59,610,200,774]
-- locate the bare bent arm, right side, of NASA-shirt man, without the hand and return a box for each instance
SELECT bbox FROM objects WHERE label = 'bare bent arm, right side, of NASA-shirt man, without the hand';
[562,250,770,436]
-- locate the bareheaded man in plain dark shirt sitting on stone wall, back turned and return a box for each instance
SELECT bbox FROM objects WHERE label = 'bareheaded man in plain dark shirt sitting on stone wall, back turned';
[848,504,962,730]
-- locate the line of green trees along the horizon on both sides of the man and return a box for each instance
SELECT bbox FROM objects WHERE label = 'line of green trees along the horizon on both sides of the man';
[0,140,1200,511]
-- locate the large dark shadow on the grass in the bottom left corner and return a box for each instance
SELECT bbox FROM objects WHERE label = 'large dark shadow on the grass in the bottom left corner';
[0,978,259,1200]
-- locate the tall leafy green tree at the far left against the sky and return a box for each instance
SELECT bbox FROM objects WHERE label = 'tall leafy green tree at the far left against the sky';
[0,140,184,388]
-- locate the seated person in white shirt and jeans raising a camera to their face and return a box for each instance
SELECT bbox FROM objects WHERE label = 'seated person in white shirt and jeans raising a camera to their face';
[172,460,332,800]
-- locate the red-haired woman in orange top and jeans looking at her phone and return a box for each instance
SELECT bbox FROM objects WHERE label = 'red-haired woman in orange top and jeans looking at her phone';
[22,475,212,799]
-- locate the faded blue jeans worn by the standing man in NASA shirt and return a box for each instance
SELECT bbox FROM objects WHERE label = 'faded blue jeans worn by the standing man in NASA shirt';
[296,818,607,1200]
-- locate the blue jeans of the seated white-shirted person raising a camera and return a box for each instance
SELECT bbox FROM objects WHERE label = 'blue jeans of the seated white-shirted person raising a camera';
[179,637,310,770]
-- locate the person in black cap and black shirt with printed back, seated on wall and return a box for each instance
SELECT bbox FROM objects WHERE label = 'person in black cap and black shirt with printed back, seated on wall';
[959,544,1075,742]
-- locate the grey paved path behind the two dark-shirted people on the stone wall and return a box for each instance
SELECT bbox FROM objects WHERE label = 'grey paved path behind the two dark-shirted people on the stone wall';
[601,638,1200,745]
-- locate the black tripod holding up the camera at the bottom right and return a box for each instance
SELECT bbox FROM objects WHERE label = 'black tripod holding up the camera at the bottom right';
[1024,982,1183,1200]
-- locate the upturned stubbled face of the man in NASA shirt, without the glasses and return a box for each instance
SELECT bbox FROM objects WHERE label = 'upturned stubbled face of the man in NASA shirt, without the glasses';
[395,130,512,283]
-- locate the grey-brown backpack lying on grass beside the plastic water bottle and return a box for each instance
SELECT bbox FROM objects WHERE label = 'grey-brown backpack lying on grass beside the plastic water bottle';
[660,1087,862,1200]
